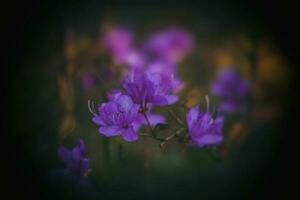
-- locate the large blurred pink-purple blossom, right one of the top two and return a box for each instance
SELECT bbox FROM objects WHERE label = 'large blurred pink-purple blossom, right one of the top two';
[143,28,193,62]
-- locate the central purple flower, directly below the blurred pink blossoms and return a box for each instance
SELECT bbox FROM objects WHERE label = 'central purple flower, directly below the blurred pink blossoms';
[123,73,178,112]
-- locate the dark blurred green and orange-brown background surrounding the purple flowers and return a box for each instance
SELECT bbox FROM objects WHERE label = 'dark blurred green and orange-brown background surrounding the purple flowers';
[2,0,299,199]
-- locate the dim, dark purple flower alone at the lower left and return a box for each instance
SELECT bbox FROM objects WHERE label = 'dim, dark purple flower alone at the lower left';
[58,139,89,176]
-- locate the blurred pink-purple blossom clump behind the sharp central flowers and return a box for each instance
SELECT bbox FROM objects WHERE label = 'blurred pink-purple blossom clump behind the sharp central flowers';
[103,27,193,91]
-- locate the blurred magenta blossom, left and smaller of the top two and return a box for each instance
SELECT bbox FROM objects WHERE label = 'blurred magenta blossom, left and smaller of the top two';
[103,27,133,64]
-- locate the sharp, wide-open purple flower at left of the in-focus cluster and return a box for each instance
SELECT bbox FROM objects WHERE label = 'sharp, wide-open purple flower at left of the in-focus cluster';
[93,93,139,142]
